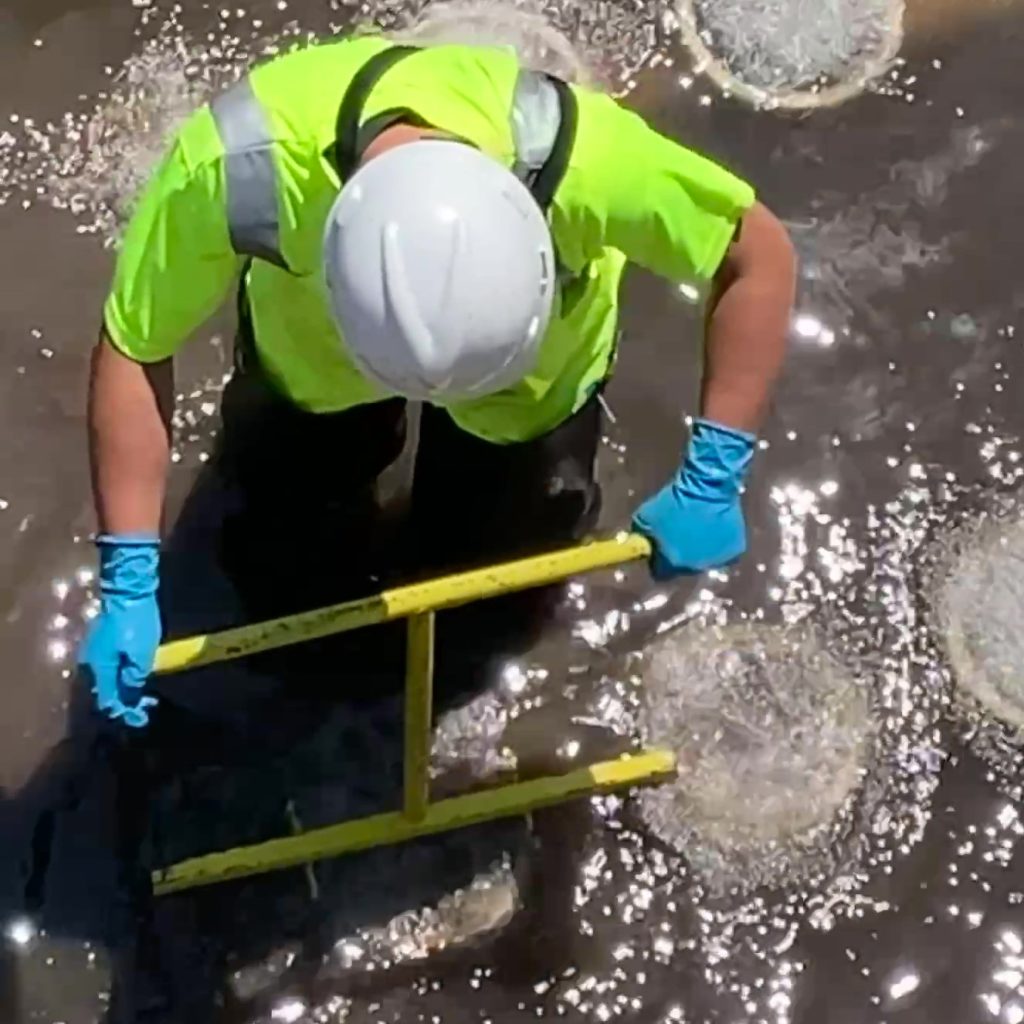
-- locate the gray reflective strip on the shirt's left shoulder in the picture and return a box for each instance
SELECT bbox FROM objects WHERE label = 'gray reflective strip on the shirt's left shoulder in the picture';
[210,77,289,270]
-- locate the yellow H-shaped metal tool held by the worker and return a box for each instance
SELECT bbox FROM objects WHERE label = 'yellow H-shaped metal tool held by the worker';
[154,535,676,894]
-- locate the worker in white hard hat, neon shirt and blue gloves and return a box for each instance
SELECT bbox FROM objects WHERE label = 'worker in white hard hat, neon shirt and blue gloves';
[80,35,796,727]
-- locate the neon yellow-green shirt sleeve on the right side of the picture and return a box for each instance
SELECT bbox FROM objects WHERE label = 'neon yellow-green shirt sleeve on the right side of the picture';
[556,89,755,283]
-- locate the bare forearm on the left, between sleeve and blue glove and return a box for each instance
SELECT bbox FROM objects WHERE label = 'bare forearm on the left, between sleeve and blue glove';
[88,333,174,534]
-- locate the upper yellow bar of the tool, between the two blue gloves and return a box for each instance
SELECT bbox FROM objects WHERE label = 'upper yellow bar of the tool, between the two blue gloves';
[154,534,651,673]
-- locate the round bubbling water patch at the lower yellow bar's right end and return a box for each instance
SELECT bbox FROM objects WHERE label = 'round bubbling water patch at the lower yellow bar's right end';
[639,623,872,890]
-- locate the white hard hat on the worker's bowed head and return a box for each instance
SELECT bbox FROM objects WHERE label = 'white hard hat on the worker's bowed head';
[324,139,555,402]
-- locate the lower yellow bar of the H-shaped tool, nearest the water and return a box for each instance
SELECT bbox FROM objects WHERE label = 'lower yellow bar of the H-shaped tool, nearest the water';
[153,751,676,895]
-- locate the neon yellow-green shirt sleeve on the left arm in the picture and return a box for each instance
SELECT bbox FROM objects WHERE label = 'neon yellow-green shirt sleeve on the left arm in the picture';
[103,108,242,362]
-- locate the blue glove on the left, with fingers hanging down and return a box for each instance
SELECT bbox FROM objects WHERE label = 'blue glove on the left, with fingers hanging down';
[79,534,163,729]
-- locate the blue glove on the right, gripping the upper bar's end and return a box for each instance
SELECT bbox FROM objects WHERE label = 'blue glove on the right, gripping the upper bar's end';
[633,420,757,580]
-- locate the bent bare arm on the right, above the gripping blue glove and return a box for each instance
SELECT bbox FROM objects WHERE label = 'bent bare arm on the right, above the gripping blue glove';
[700,207,796,432]
